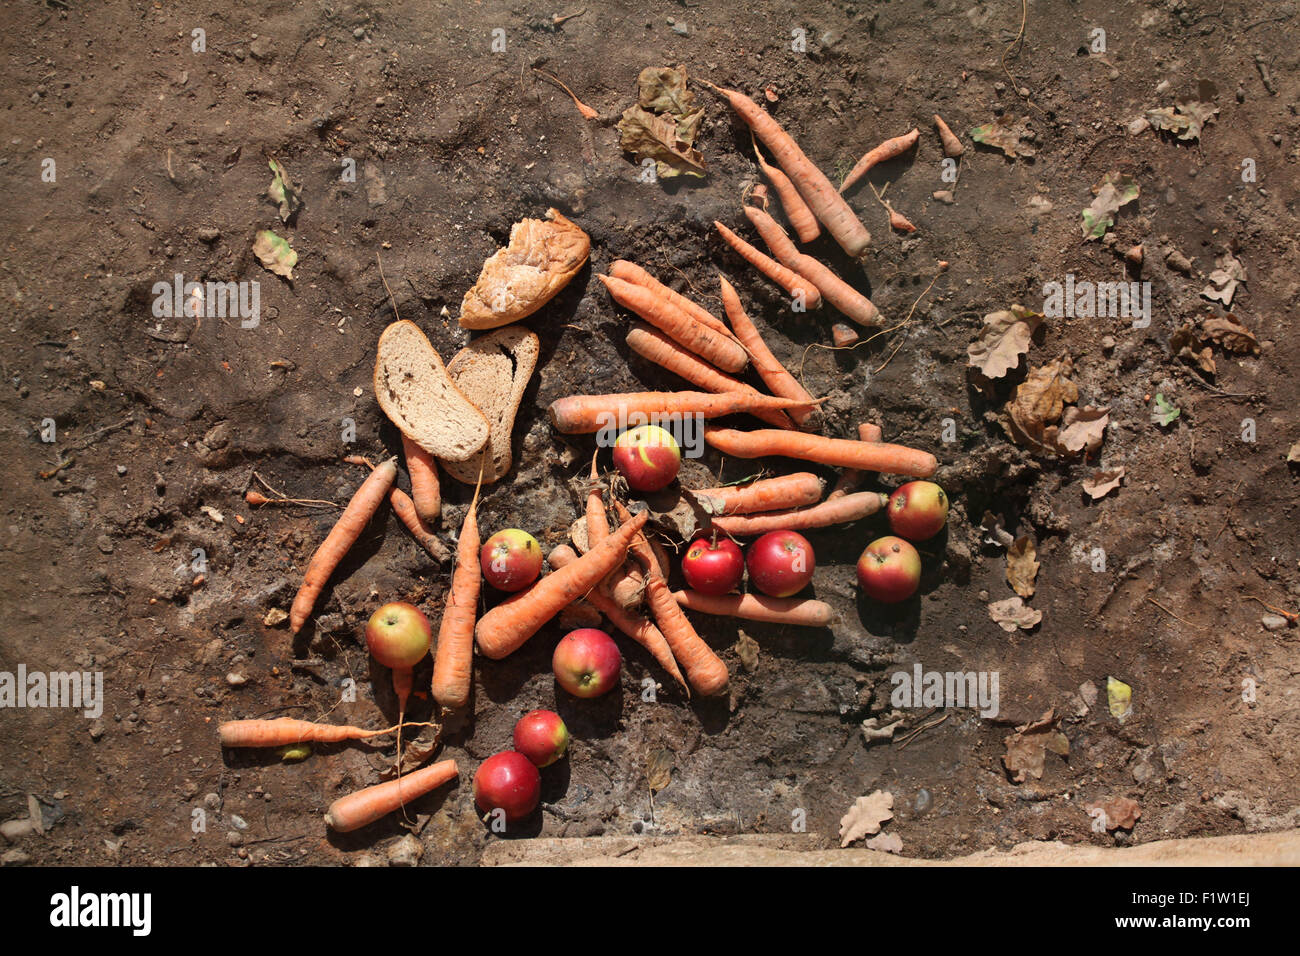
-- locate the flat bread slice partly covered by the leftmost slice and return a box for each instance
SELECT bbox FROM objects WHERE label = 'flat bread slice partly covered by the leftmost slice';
[442,325,541,485]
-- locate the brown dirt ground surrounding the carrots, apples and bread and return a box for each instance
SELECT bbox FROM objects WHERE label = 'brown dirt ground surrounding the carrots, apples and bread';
[0,0,1300,865]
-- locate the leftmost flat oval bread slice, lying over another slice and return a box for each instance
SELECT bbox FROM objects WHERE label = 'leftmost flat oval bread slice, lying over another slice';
[374,320,490,462]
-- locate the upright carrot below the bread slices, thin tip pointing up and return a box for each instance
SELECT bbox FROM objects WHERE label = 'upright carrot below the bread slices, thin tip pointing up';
[430,460,488,710]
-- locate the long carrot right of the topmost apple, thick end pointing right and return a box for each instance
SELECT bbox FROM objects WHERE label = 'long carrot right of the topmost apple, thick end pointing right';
[705,427,939,477]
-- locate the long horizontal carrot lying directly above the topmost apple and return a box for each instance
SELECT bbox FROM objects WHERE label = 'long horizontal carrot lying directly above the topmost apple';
[549,390,802,434]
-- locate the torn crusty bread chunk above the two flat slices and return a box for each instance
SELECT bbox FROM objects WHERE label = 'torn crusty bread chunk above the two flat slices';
[460,209,592,329]
